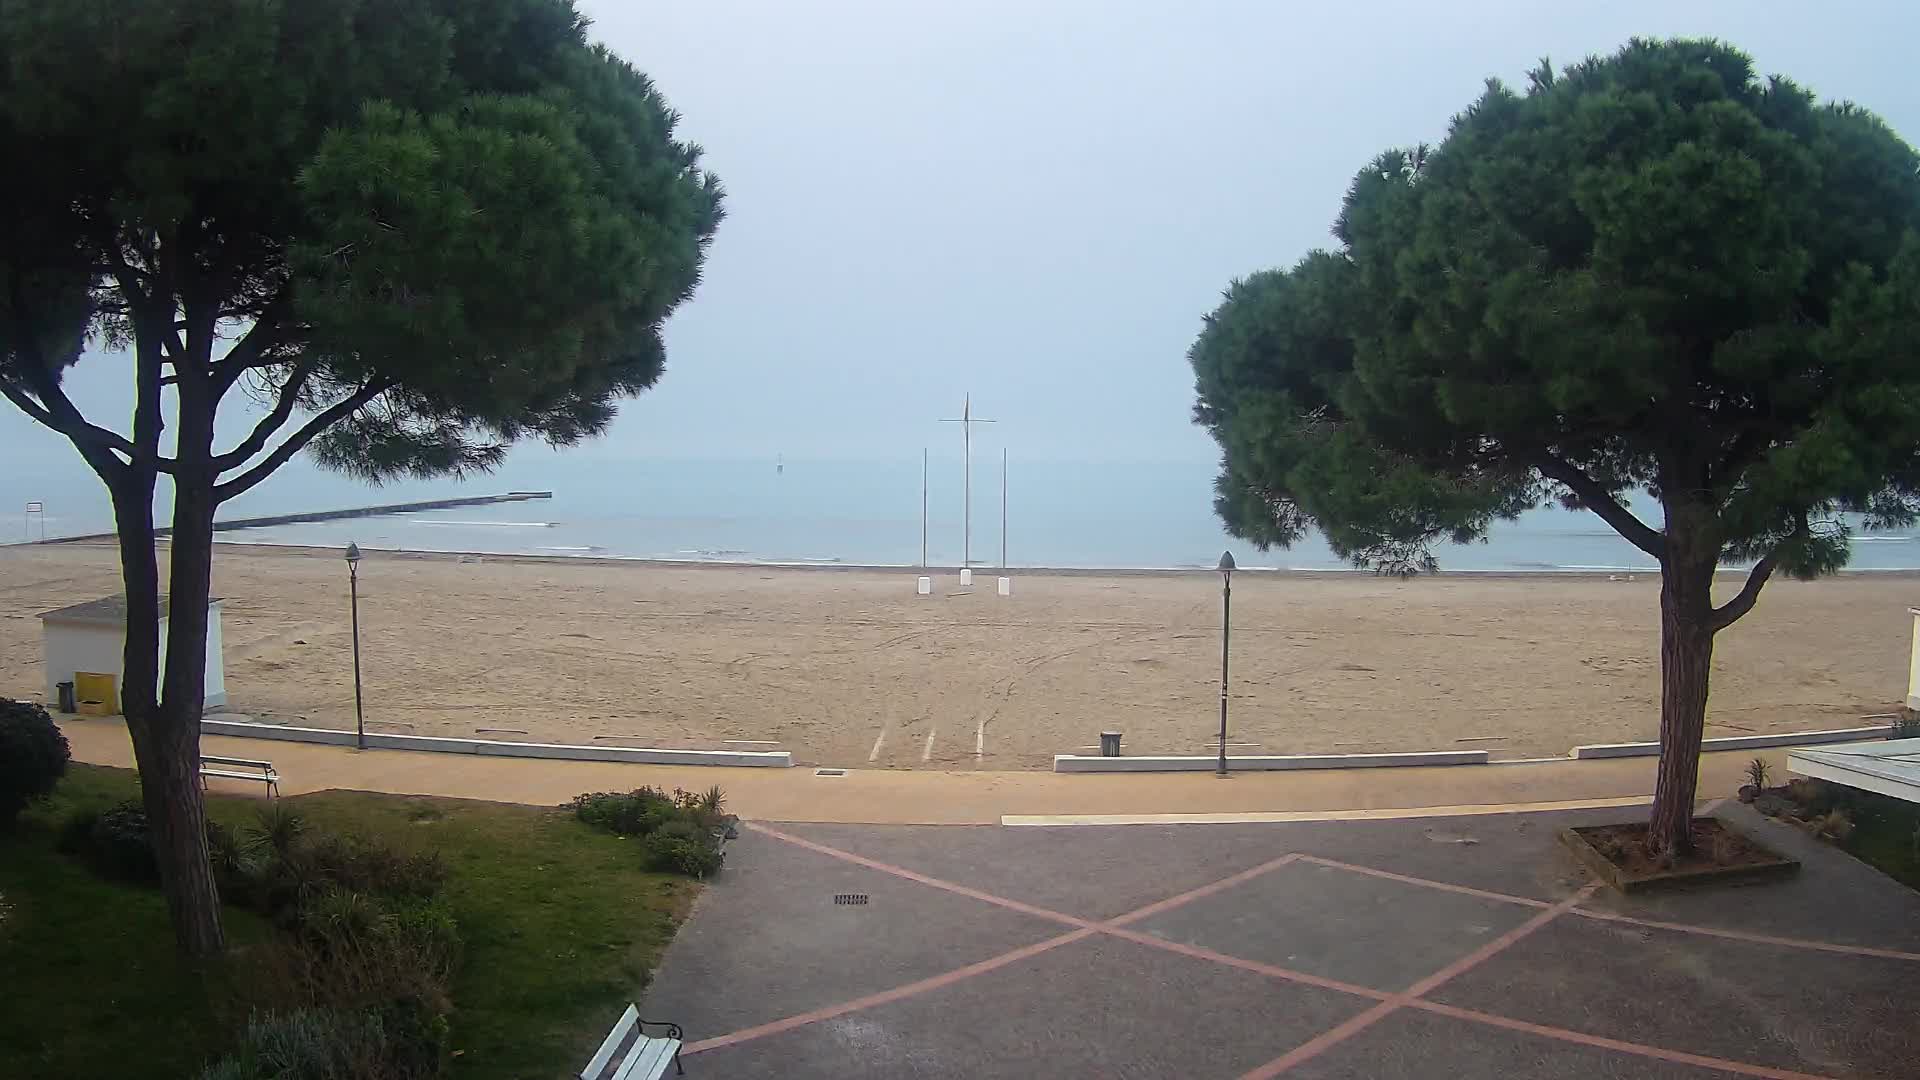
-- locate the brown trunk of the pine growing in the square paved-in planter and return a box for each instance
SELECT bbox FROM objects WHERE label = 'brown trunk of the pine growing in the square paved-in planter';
[1647,545,1715,855]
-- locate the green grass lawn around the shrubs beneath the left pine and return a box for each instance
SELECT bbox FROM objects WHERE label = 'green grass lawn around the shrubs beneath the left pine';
[0,765,699,1080]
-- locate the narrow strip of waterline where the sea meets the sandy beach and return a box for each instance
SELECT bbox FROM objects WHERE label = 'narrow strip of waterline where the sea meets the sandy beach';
[23,536,1920,580]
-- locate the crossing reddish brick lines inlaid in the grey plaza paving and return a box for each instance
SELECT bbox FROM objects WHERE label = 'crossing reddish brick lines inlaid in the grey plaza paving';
[682,822,1920,1080]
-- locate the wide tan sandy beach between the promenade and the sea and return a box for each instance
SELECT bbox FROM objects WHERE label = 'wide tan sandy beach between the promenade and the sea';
[0,544,1920,769]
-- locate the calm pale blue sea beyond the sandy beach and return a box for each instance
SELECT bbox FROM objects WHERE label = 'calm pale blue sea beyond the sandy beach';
[11,455,1920,573]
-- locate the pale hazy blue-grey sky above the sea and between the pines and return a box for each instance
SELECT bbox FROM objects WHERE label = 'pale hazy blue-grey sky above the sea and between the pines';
[0,0,1920,478]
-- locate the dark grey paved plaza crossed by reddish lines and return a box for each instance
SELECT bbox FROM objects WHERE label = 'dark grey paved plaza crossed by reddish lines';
[645,805,1920,1080]
